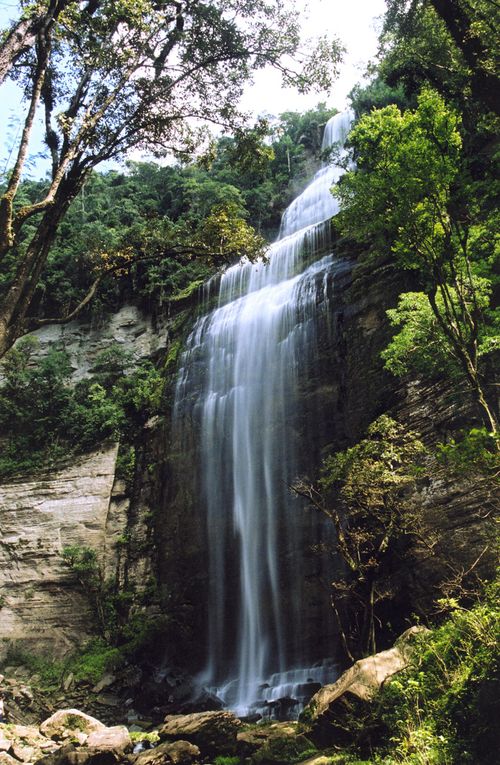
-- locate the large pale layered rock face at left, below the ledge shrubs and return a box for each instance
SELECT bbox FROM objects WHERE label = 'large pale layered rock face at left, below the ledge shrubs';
[0,445,126,658]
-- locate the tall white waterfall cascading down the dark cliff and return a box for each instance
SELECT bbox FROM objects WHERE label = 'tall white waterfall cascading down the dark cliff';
[174,113,352,714]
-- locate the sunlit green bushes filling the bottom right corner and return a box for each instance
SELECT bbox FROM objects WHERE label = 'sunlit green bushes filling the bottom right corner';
[377,582,500,765]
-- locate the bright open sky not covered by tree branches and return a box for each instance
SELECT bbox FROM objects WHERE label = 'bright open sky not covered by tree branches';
[0,0,385,176]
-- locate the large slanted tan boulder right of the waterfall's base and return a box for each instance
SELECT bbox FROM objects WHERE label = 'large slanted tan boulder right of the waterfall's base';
[303,627,427,746]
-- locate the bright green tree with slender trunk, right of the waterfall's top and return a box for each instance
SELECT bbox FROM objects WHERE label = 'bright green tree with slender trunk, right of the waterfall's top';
[336,88,497,432]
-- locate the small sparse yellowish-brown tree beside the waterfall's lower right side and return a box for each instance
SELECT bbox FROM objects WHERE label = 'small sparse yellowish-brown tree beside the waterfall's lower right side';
[292,415,430,660]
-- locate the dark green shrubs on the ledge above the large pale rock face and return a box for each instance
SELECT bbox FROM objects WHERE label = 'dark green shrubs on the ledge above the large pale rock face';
[0,338,164,477]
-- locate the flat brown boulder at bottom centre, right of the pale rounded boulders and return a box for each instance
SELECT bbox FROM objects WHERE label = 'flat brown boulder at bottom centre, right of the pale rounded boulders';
[159,711,241,757]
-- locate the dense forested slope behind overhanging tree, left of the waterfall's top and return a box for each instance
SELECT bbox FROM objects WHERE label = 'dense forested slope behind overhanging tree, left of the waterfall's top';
[4,104,340,317]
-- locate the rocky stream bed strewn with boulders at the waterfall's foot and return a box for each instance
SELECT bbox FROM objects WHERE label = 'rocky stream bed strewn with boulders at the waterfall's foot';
[0,628,420,765]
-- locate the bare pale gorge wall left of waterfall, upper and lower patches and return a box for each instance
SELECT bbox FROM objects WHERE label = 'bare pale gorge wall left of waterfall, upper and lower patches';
[0,305,167,659]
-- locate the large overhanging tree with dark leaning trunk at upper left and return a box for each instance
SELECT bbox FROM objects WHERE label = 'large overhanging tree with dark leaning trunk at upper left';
[0,0,341,356]
